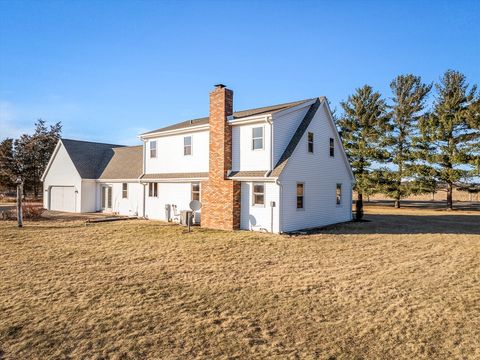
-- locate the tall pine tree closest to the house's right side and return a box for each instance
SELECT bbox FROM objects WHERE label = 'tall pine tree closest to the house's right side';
[337,85,388,220]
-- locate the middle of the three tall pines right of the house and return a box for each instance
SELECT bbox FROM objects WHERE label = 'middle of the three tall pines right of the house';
[383,74,432,208]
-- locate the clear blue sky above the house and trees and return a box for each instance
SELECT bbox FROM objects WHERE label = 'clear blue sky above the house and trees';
[0,0,480,144]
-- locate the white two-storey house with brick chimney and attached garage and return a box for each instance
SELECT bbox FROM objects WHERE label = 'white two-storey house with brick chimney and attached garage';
[42,85,354,232]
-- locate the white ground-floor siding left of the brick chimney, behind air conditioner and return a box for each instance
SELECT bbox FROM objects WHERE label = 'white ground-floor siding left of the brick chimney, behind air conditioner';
[145,182,201,221]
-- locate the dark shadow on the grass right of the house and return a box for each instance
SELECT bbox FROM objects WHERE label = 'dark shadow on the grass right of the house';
[308,213,480,235]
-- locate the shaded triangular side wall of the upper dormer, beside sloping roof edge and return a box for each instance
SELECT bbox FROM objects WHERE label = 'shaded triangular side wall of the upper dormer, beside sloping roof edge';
[273,106,310,166]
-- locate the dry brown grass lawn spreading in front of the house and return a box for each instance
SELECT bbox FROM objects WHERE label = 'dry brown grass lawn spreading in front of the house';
[0,208,480,359]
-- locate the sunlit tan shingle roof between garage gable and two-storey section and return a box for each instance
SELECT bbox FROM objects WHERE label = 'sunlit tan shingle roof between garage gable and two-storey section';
[100,145,143,180]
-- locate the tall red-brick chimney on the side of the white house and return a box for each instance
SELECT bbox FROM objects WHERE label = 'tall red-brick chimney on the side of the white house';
[202,84,240,230]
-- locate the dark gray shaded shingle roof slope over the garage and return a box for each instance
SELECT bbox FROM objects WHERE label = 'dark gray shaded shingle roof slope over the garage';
[61,139,123,179]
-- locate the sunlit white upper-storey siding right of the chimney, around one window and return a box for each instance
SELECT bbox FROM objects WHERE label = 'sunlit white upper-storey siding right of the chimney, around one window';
[232,121,271,171]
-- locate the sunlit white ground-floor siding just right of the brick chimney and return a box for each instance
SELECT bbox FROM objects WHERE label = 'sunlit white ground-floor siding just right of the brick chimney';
[240,182,279,233]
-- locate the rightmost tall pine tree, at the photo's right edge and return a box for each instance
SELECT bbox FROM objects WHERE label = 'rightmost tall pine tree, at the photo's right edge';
[419,70,480,210]
